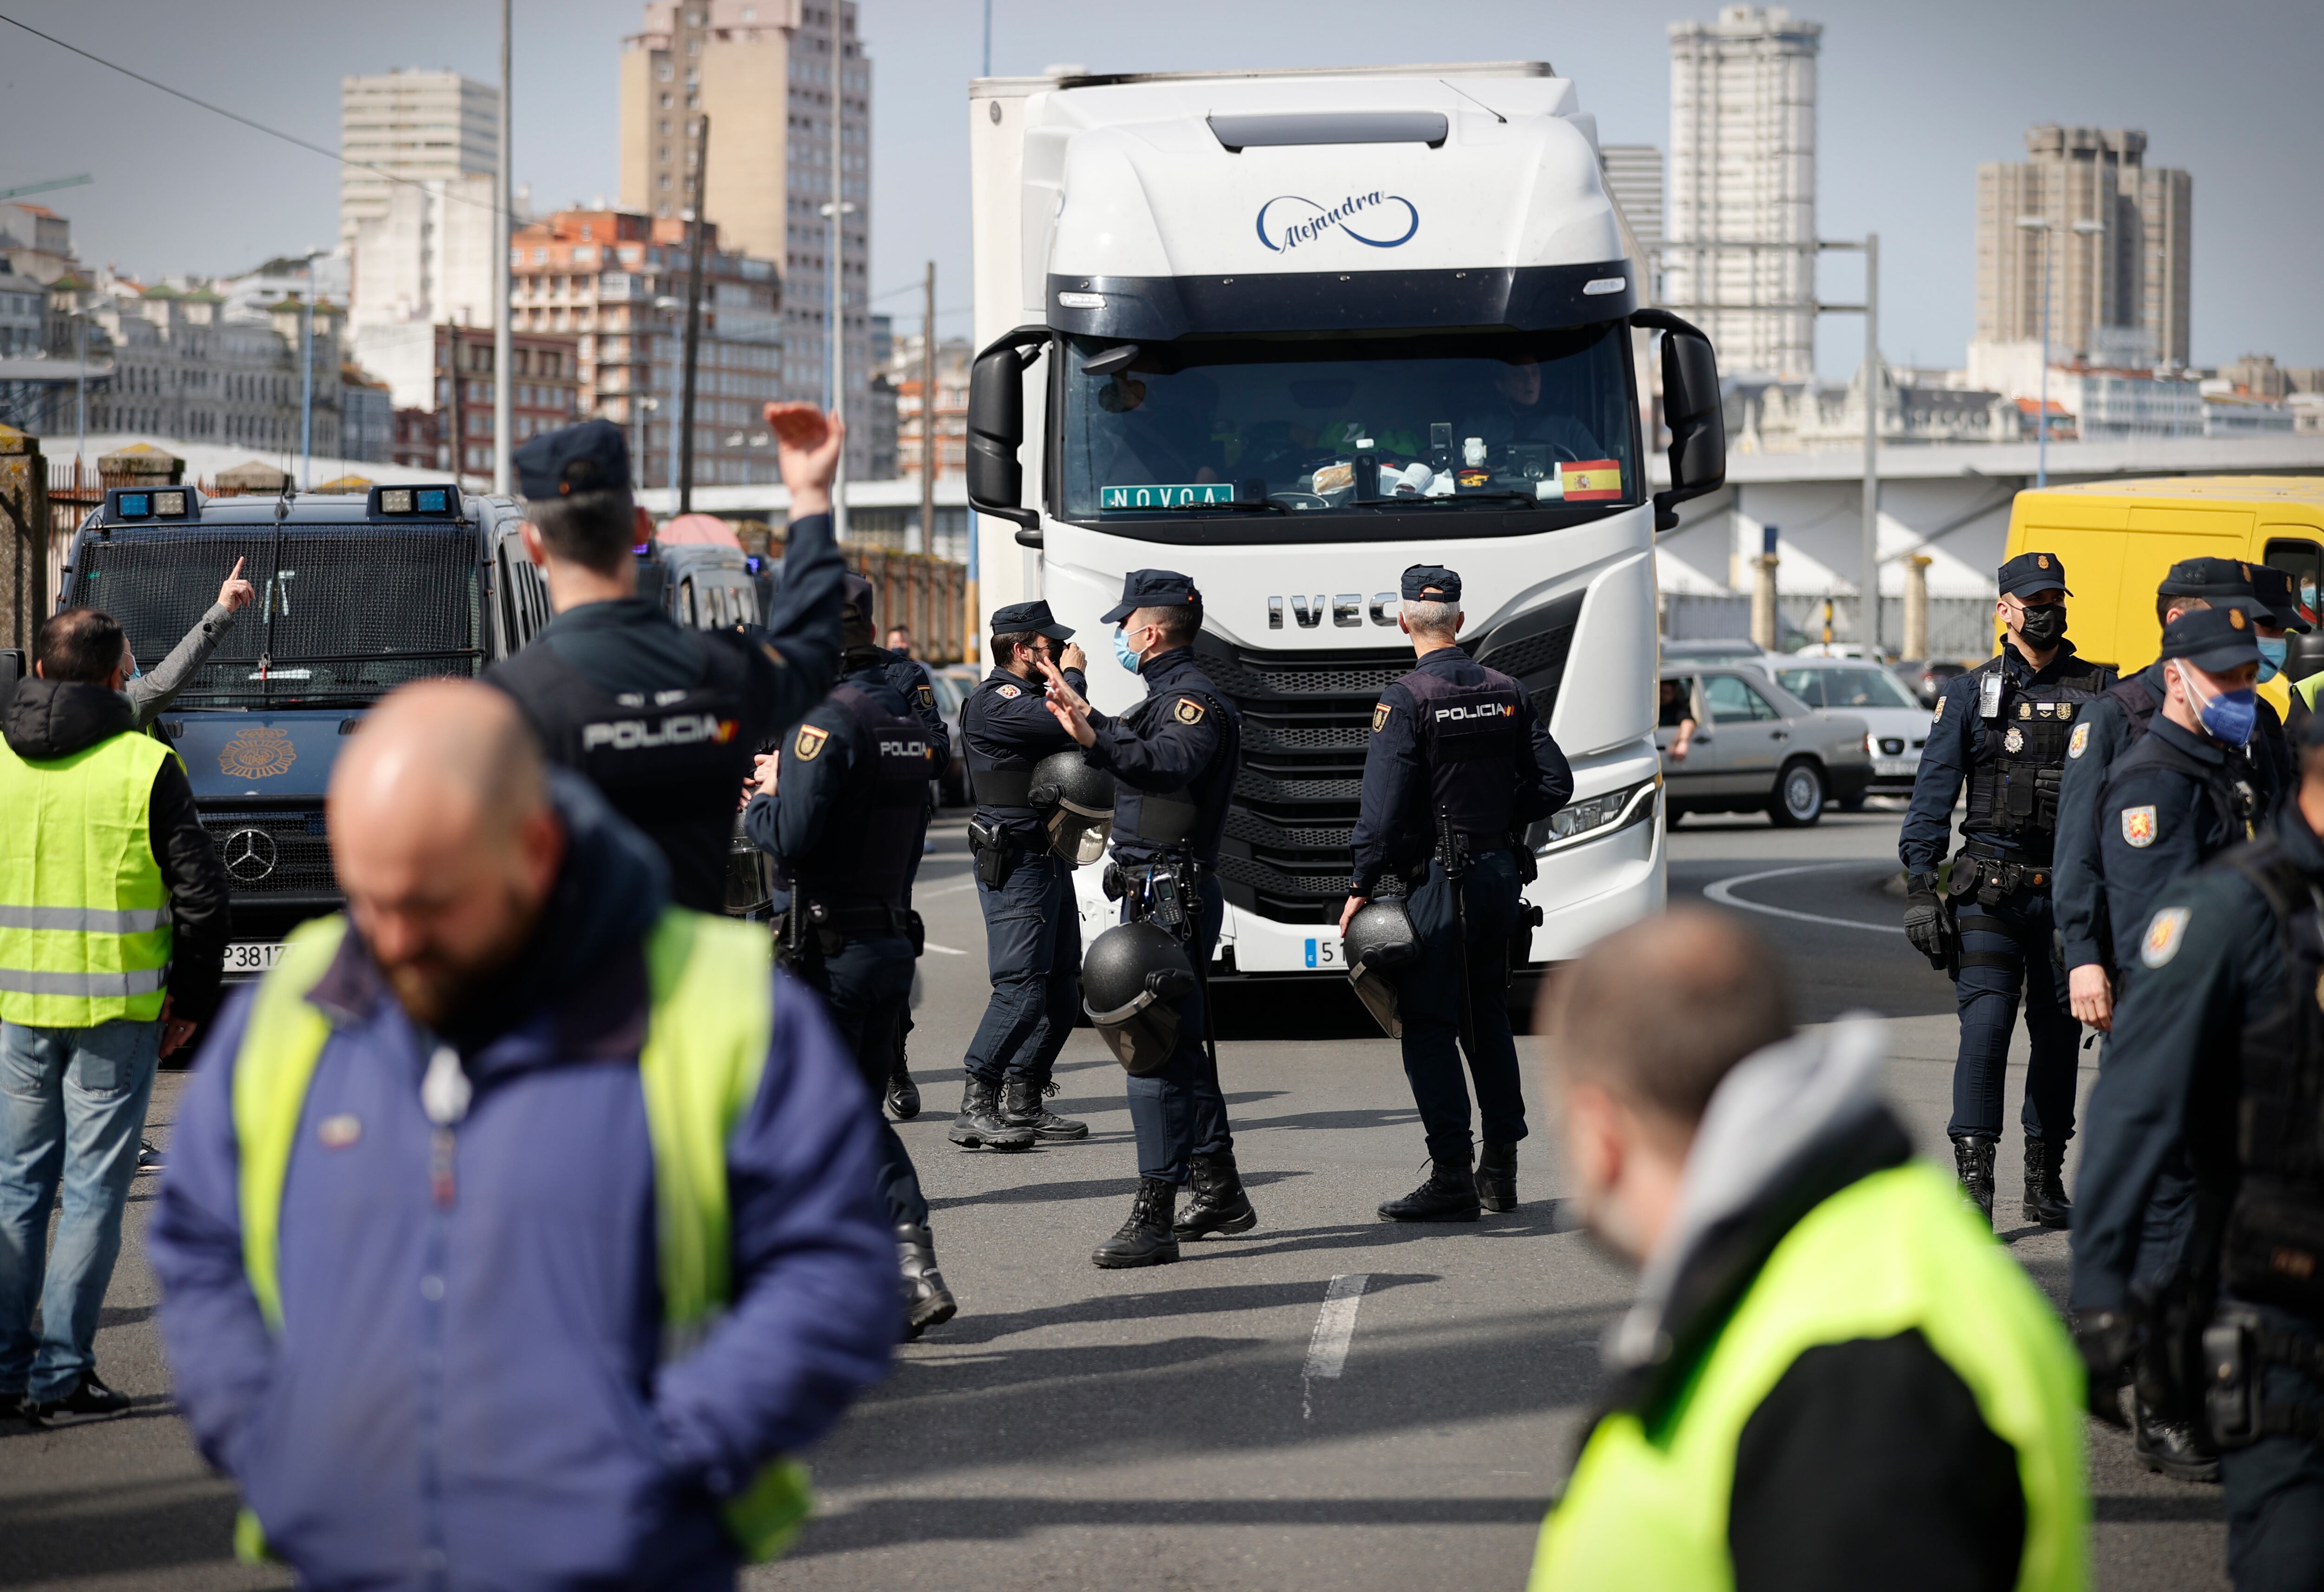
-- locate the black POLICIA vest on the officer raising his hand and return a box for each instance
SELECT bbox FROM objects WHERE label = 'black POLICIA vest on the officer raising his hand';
[490,634,751,911]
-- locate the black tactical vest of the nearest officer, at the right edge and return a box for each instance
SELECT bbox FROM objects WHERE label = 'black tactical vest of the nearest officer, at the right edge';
[2189,834,2324,1315]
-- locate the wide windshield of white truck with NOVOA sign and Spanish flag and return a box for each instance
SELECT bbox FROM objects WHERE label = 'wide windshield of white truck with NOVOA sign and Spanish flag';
[1062,321,1645,523]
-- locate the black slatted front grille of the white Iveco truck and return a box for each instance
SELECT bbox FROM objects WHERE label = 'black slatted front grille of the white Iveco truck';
[1195,593,1583,923]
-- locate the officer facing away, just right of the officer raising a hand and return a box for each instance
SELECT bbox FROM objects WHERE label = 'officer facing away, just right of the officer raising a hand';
[744,574,957,1336]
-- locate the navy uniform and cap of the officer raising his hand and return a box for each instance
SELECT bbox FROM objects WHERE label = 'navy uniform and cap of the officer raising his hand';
[486,421,841,911]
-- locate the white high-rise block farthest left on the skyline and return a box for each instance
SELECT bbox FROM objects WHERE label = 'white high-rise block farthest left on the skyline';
[339,70,500,246]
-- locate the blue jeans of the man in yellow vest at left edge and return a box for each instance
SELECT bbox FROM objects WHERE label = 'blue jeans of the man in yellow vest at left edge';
[0,1020,160,1399]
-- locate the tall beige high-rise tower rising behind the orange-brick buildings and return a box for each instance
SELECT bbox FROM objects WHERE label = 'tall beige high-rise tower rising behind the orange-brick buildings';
[621,0,872,479]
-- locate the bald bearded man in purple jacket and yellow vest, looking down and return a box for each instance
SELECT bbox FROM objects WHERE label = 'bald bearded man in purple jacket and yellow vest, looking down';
[151,681,899,1587]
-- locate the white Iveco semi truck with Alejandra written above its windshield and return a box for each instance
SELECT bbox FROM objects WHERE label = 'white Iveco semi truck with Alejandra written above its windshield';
[969,63,1724,995]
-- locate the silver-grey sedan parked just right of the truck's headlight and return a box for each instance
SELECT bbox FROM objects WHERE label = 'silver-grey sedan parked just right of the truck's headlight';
[1655,662,1873,830]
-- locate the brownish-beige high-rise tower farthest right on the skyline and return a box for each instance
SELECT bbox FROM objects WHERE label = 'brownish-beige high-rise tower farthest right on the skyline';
[1975,126,2194,367]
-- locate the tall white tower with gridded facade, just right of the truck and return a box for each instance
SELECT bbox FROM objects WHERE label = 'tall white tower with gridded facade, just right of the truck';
[1662,5,1824,377]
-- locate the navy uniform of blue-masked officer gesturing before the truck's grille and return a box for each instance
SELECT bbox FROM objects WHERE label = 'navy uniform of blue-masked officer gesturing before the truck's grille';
[1081,569,1257,1264]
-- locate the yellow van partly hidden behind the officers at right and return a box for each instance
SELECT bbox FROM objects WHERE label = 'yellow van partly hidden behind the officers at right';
[2003,476,2324,713]
